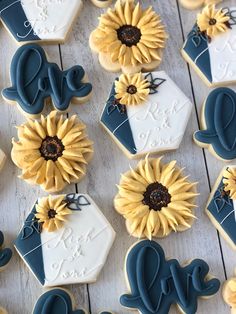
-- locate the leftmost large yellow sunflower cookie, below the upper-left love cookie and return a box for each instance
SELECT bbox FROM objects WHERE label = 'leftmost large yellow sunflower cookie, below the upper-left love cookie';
[11,111,93,193]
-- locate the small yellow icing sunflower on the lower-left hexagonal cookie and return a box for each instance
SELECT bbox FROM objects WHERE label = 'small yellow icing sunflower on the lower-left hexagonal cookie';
[35,195,71,232]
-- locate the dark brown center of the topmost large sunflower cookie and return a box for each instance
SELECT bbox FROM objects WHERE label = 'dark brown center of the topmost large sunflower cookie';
[117,25,142,47]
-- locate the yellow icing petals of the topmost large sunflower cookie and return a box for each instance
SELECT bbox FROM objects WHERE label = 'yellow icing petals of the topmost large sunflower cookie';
[93,0,167,66]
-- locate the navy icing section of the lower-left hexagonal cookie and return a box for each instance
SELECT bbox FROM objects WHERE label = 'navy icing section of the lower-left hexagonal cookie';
[15,207,45,285]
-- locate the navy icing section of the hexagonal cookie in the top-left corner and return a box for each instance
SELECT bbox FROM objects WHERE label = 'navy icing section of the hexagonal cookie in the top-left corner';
[0,0,40,42]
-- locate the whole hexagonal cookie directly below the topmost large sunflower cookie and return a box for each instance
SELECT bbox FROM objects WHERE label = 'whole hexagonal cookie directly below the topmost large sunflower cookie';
[101,71,192,158]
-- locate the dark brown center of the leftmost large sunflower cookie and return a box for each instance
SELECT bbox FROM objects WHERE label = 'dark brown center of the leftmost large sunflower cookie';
[39,136,65,161]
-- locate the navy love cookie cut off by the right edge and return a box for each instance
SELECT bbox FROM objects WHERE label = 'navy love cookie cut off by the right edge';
[193,87,236,161]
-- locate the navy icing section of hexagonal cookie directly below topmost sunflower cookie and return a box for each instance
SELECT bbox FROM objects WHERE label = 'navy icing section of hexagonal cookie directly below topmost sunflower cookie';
[101,84,137,155]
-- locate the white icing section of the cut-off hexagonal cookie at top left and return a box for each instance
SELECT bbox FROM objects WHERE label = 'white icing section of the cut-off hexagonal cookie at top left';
[17,0,82,41]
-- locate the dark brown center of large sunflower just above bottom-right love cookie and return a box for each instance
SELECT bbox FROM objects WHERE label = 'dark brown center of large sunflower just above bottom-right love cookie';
[143,182,171,211]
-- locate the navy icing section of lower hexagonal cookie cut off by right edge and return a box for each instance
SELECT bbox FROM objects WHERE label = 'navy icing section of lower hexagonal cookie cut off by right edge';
[207,177,236,245]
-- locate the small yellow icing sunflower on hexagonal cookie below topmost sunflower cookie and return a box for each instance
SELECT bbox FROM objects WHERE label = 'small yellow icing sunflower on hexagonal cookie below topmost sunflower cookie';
[115,73,150,106]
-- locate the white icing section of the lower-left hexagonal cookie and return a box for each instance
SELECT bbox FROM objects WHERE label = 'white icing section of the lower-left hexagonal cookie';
[37,195,115,287]
